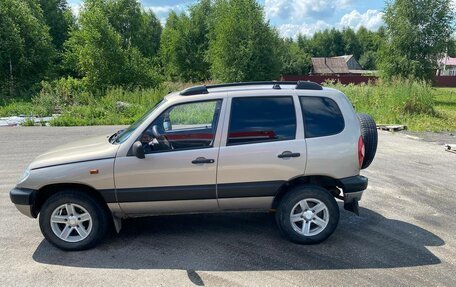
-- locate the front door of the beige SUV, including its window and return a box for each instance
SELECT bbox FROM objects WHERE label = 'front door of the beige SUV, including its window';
[114,100,222,215]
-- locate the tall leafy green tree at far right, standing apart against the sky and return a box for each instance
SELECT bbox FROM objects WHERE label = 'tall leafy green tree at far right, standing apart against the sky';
[380,0,454,80]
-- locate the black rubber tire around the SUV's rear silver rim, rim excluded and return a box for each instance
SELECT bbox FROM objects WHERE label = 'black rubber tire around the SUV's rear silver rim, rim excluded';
[276,186,339,245]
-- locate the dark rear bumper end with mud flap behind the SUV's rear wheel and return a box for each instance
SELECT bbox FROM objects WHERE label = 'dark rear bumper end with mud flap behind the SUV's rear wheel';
[339,175,368,215]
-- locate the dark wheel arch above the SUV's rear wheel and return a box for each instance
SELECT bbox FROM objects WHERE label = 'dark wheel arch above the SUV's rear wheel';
[271,175,341,210]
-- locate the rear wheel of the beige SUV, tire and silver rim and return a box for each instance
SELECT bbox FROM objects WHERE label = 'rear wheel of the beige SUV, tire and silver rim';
[276,186,339,244]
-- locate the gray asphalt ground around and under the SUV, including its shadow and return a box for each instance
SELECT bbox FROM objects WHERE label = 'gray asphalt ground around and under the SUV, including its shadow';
[0,127,456,286]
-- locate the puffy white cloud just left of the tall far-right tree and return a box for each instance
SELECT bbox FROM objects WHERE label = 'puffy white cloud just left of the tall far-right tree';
[339,10,384,30]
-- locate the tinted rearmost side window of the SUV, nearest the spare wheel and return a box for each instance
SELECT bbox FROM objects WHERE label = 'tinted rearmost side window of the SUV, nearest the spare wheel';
[299,97,345,138]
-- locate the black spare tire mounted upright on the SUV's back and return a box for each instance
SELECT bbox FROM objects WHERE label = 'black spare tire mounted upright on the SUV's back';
[358,114,378,169]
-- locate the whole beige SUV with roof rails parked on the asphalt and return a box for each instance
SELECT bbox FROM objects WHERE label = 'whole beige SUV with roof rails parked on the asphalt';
[10,82,377,250]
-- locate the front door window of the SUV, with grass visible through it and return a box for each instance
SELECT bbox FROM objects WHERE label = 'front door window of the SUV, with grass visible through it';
[140,100,222,153]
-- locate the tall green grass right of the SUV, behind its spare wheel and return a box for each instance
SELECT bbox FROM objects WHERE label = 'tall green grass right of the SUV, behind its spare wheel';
[332,81,456,132]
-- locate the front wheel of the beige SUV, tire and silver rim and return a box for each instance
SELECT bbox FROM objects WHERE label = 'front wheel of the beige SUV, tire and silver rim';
[39,191,109,251]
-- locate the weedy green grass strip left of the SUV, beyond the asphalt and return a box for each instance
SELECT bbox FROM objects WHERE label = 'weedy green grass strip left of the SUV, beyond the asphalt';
[0,83,185,126]
